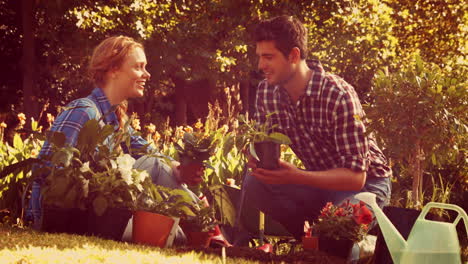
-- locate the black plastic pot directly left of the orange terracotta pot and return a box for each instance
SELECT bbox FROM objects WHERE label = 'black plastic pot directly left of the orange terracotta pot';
[88,208,132,241]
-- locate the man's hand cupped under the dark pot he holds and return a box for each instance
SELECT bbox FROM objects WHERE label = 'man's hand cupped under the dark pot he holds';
[249,160,301,184]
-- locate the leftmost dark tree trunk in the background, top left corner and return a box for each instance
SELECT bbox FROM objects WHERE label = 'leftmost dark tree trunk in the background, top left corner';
[21,0,37,117]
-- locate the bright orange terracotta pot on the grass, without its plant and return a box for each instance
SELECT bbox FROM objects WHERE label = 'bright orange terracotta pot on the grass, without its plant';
[132,211,179,248]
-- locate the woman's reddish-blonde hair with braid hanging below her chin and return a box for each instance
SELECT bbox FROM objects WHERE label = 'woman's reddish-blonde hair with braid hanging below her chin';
[88,36,144,128]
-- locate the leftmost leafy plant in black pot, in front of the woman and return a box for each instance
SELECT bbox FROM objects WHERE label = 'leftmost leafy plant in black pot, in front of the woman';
[32,129,98,234]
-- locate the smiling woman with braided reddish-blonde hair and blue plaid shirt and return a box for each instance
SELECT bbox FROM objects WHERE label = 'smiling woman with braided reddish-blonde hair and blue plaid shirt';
[27,36,203,226]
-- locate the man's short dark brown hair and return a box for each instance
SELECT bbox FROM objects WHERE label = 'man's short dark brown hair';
[253,16,307,59]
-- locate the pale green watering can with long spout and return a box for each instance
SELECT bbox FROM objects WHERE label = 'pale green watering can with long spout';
[354,192,468,264]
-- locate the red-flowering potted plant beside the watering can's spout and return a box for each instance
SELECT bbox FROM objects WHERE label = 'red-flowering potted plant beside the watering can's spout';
[313,201,373,258]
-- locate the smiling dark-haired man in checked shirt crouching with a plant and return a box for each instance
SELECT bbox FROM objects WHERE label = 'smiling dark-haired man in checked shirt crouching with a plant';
[244,16,391,238]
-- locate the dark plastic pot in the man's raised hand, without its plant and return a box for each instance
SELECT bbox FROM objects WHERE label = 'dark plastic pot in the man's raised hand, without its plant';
[254,141,281,170]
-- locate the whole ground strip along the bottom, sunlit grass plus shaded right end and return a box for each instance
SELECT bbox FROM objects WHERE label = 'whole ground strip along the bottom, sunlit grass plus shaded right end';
[0,223,352,264]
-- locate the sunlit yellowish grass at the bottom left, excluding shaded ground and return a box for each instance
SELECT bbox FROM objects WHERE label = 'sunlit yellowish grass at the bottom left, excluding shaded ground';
[0,224,259,264]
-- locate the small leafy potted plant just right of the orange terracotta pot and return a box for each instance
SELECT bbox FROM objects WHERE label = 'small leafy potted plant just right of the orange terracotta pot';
[181,201,218,248]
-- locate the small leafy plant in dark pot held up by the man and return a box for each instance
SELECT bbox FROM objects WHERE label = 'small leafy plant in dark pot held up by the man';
[240,113,291,170]
